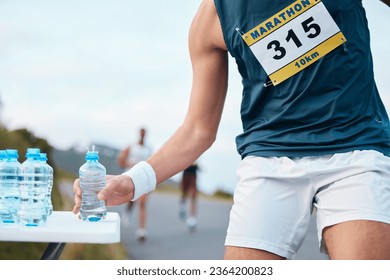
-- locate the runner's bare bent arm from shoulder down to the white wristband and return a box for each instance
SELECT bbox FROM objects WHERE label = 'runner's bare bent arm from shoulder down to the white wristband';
[148,0,228,183]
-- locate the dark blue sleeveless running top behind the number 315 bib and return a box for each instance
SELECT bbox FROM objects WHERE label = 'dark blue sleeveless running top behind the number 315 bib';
[215,0,390,158]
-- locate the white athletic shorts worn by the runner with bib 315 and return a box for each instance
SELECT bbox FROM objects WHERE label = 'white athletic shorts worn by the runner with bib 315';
[225,151,390,259]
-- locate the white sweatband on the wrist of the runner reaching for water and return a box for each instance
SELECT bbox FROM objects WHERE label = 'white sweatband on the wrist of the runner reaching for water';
[122,161,156,201]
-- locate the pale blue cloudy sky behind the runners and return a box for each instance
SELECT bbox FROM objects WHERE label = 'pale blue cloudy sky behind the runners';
[0,0,390,196]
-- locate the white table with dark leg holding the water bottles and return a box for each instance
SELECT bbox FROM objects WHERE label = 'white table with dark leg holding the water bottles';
[0,211,120,259]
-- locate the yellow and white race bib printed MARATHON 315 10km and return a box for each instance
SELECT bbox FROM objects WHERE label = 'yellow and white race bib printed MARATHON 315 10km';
[242,0,346,85]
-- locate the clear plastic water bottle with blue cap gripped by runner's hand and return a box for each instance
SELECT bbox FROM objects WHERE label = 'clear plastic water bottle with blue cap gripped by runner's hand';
[79,147,107,222]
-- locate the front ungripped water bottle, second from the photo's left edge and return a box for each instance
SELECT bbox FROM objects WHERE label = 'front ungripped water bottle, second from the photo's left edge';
[19,148,47,227]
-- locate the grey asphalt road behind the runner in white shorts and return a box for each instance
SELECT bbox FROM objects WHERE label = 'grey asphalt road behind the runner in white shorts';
[109,192,327,260]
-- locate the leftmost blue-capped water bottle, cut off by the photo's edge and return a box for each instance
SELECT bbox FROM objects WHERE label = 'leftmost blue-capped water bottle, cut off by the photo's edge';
[0,149,20,224]
